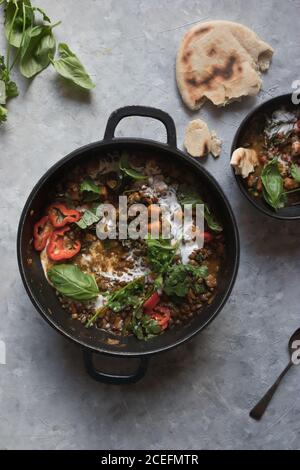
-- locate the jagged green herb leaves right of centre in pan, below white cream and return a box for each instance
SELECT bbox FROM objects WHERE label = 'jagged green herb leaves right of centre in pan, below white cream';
[164,264,208,297]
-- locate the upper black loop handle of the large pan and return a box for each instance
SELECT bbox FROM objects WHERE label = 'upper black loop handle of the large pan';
[104,106,177,147]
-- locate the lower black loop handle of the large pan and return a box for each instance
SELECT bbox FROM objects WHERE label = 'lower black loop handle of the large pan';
[83,349,148,385]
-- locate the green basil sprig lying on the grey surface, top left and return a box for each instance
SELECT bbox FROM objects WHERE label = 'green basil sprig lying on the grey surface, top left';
[0,0,95,122]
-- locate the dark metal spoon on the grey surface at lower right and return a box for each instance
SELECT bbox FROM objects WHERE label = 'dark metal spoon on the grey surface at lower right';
[249,328,300,420]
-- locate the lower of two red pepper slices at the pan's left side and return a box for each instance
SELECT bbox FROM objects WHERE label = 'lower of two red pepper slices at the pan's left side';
[47,227,81,261]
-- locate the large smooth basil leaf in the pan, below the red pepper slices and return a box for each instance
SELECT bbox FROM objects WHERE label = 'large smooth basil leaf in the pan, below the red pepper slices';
[47,264,99,301]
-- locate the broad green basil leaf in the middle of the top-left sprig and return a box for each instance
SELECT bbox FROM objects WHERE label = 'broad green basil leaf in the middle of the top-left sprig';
[20,25,56,78]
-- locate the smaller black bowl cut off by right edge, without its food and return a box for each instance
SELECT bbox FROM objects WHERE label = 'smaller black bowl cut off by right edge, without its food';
[231,94,300,220]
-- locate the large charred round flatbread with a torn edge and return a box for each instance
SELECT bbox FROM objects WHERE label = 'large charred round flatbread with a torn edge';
[176,21,274,110]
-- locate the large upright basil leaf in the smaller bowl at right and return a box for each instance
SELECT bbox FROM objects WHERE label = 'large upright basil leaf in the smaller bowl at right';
[261,158,285,210]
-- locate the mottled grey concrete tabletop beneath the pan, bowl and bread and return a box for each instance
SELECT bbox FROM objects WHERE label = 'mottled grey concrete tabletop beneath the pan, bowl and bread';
[0,0,300,449]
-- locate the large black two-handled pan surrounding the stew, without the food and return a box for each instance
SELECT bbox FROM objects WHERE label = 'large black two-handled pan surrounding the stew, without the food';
[17,106,239,383]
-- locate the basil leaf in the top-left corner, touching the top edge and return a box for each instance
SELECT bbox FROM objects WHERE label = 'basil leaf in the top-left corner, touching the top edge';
[4,0,34,48]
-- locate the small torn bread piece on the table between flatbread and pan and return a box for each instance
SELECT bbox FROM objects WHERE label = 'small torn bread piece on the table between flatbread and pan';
[184,119,222,157]
